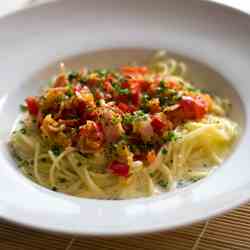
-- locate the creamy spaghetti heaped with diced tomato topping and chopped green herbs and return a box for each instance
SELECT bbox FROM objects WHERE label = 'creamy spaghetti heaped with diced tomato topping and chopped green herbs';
[9,51,239,199]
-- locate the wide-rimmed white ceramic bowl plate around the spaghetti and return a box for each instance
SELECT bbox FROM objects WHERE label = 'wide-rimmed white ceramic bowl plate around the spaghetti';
[0,0,250,235]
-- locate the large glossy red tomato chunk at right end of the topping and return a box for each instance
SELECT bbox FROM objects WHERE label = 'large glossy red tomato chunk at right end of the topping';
[180,96,206,119]
